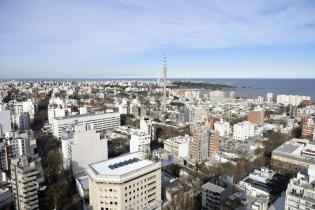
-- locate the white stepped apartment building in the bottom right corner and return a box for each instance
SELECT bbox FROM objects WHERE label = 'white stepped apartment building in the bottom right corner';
[284,166,315,210]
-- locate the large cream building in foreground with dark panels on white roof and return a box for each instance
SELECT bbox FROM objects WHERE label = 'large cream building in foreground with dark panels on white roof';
[88,152,161,210]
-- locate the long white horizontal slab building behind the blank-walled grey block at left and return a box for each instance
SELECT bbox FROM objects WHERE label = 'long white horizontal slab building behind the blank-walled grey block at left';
[52,112,120,138]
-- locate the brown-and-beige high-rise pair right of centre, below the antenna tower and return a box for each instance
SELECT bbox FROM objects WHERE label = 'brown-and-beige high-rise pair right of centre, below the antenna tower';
[189,122,220,163]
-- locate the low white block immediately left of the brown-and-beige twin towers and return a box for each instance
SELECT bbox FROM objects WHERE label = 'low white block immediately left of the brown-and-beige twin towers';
[164,135,190,158]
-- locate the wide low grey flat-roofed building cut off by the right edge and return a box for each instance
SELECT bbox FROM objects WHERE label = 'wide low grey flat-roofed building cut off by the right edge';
[271,138,315,167]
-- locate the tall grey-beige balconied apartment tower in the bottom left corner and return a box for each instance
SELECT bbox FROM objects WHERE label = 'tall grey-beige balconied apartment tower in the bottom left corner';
[11,155,43,210]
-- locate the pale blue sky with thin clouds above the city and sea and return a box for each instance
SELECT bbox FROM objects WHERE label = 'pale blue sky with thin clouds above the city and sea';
[0,0,315,79]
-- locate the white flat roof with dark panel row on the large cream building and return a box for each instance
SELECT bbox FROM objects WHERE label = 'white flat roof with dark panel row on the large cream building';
[90,152,155,176]
